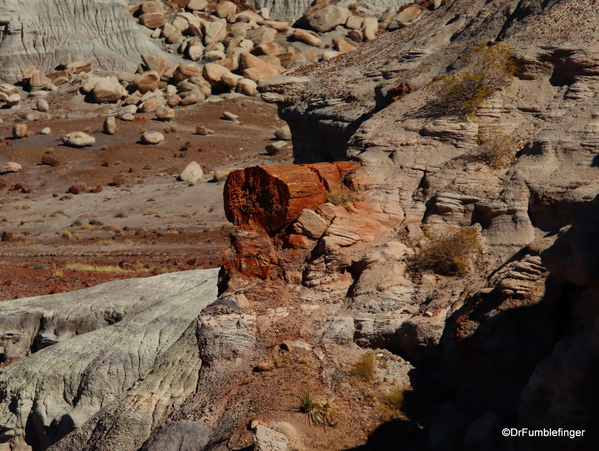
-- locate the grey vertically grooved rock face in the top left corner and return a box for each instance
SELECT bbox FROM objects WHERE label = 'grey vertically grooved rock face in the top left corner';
[0,0,180,83]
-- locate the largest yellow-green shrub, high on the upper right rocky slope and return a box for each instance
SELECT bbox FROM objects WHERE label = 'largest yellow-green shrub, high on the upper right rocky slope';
[431,42,518,117]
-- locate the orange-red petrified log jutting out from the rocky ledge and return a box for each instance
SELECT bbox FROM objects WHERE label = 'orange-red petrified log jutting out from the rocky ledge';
[224,161,356,233]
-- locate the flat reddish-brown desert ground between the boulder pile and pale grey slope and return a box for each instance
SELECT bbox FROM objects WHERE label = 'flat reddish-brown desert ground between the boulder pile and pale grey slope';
[0,94,292,300]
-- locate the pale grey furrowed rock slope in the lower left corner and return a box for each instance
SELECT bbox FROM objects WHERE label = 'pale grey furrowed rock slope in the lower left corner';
[0,270,216,451]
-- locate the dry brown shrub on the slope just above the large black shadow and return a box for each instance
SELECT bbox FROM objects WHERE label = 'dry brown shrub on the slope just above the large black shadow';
[409,227,480,277]
